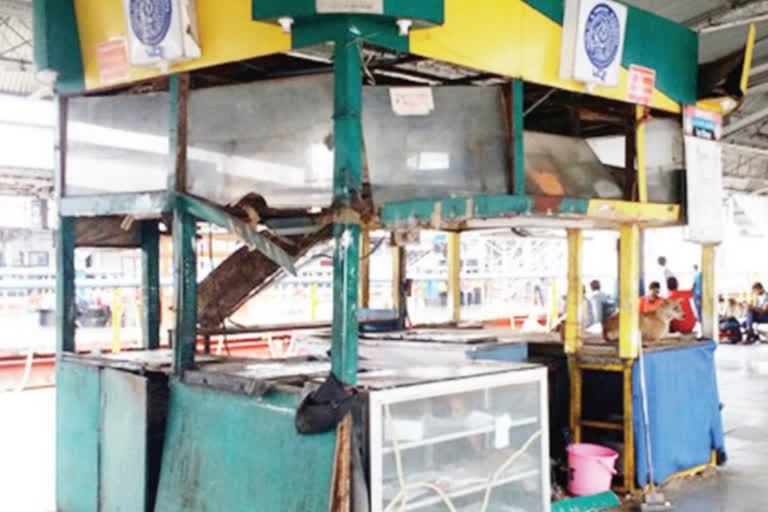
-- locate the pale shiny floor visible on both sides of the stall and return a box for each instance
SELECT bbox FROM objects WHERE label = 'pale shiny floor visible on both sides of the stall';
[0,346,768,512]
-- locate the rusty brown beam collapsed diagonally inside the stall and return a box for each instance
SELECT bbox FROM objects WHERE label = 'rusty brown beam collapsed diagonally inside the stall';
[197,227,331,328]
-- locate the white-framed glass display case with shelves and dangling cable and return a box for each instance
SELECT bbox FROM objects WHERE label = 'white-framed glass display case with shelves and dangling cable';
[359,362,550,512]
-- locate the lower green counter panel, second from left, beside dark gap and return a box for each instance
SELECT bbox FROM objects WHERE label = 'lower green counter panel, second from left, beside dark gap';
[99,369,149,512]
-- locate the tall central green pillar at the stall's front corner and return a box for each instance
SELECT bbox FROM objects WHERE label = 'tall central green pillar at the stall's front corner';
[331,33,363,384]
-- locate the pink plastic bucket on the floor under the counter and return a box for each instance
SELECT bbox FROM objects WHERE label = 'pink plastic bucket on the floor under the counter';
[568,443,619,496]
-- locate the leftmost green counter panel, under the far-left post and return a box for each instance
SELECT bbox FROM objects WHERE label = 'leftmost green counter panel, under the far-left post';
[56,360,100,512]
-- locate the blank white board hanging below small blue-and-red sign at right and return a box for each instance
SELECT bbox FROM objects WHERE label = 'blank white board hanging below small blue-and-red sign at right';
[685,137,725,245]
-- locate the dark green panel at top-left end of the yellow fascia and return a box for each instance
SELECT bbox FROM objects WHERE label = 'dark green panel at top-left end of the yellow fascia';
[32,0,85,94]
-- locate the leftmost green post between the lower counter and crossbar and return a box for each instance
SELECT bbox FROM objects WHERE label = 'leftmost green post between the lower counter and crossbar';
[56,217,77,356]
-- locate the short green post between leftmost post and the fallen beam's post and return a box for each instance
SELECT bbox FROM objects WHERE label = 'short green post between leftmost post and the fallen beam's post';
[141,220,160,350]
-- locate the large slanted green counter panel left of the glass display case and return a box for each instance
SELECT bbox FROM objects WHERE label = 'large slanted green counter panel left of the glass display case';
[155,381,336,512]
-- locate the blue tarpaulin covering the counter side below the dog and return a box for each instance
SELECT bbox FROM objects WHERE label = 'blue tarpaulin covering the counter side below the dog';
[632,342,725,487]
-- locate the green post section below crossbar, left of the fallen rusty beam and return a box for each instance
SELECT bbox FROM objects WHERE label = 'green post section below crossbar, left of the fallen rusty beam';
[173,207,197,373]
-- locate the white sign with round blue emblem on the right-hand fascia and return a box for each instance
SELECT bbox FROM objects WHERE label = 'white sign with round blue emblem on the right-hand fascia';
[560,0,627,87]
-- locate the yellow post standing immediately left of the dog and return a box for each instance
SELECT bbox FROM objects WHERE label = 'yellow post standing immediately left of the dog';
[619,225,641,359]
